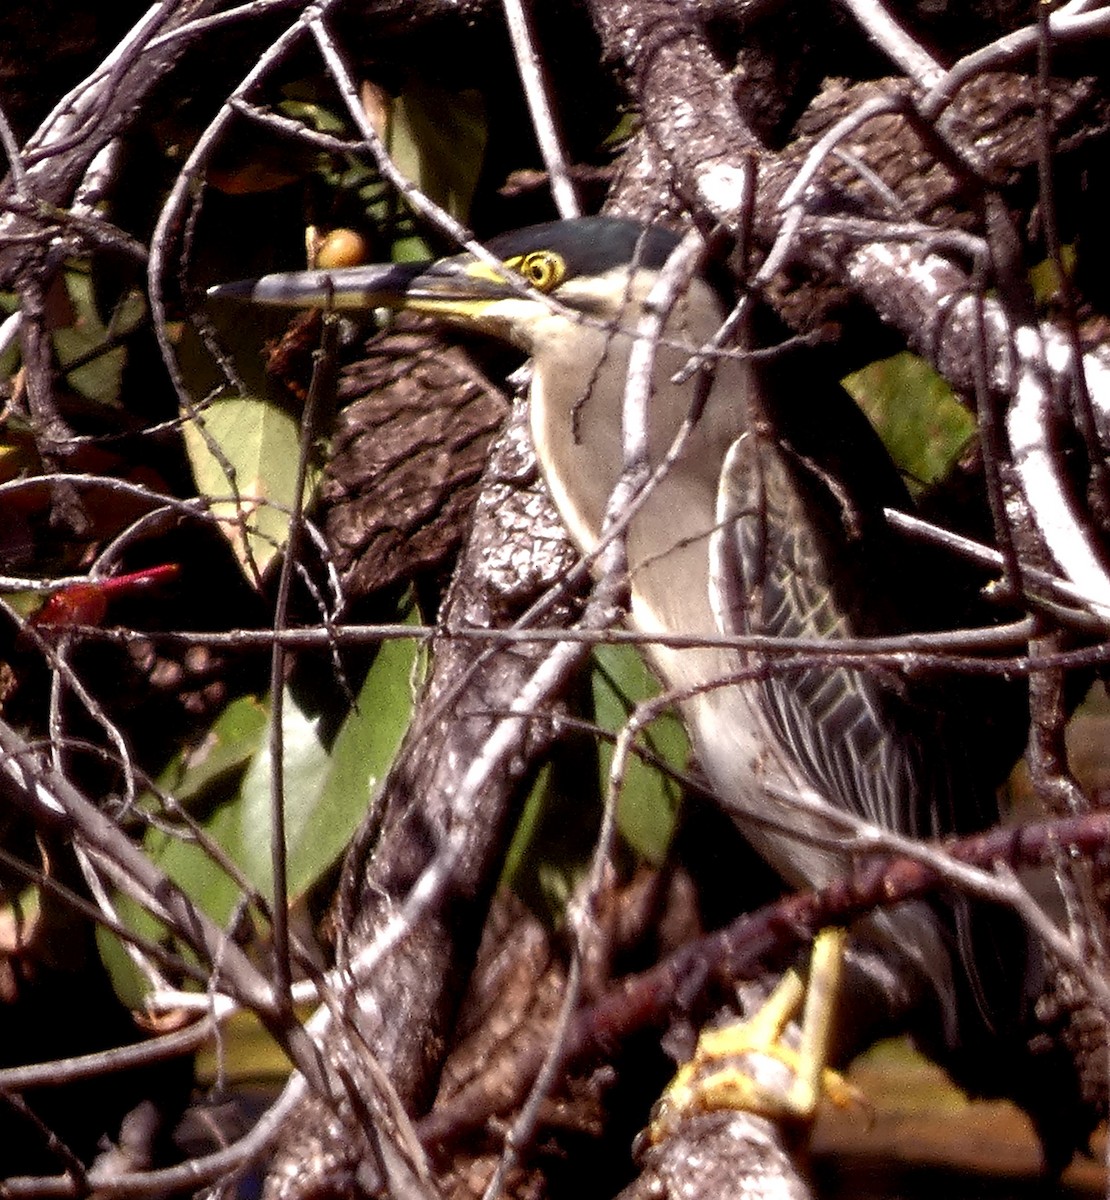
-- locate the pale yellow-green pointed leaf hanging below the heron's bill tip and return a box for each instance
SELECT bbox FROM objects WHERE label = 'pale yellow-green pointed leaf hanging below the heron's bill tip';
[185,396,316,578]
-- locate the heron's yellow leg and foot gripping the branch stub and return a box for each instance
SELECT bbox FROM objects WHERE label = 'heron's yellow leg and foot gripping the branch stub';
[648,929,859,1142]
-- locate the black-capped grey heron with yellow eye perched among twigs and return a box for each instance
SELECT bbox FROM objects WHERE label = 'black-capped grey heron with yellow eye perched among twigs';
[212,217,1076,1165]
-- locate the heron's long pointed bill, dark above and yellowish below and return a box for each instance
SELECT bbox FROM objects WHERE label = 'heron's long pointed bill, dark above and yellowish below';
[208,254,521,312]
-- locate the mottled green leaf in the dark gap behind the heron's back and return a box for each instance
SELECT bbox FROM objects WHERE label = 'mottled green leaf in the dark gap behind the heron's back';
[844,353,976,491]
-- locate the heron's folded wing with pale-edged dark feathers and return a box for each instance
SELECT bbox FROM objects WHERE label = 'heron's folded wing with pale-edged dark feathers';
[710,433,960,836]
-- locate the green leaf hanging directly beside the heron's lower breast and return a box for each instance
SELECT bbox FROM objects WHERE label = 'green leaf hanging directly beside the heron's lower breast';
[592,646,690,864]
